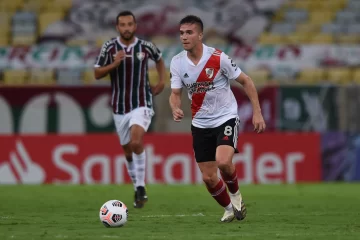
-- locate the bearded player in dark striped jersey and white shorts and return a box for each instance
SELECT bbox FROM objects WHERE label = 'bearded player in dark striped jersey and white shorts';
[94,11,165,208]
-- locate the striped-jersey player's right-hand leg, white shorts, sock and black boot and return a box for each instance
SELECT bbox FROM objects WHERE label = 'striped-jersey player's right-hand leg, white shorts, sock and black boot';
[130,107,154,207]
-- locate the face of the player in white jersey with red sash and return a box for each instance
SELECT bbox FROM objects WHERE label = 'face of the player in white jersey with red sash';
[180,23,202,51]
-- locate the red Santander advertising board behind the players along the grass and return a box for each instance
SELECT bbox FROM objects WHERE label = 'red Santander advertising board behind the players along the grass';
[0,133,322,184]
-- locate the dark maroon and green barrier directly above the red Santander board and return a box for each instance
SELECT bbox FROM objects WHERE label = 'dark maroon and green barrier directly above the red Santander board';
[0,86,360,135]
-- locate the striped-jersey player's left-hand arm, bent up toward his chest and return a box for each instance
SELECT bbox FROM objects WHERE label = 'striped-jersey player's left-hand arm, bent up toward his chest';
[94,40,125,79]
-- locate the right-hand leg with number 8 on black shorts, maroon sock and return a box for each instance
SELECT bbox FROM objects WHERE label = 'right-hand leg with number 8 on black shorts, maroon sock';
[216,119,246,220]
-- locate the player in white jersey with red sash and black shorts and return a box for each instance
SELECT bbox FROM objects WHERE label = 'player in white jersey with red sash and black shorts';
[169,15,265,222]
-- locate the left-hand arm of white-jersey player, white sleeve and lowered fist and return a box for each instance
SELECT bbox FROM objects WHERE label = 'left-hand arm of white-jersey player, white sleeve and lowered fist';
[169,59,184,122]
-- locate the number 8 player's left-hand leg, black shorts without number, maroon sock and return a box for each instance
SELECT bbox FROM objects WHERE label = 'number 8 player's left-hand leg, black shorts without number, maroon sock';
[191,126,234,222]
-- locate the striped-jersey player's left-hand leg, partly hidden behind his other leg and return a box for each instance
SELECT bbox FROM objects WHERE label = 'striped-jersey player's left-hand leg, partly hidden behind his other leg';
[113,114,136,207]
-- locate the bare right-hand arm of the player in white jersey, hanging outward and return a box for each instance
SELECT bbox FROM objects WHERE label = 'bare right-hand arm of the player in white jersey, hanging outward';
[235,72,266,133]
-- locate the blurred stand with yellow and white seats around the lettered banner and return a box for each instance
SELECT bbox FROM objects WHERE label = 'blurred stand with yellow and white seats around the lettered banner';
[0,0,360,85]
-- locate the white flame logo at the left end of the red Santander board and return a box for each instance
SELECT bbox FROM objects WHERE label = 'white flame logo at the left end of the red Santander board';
[0,141,46,184]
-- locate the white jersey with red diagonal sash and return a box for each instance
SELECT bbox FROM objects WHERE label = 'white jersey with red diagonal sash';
[170,45,241,128]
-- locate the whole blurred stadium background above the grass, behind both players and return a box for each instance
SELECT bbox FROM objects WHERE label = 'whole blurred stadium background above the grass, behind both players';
[0,0,360,183]
